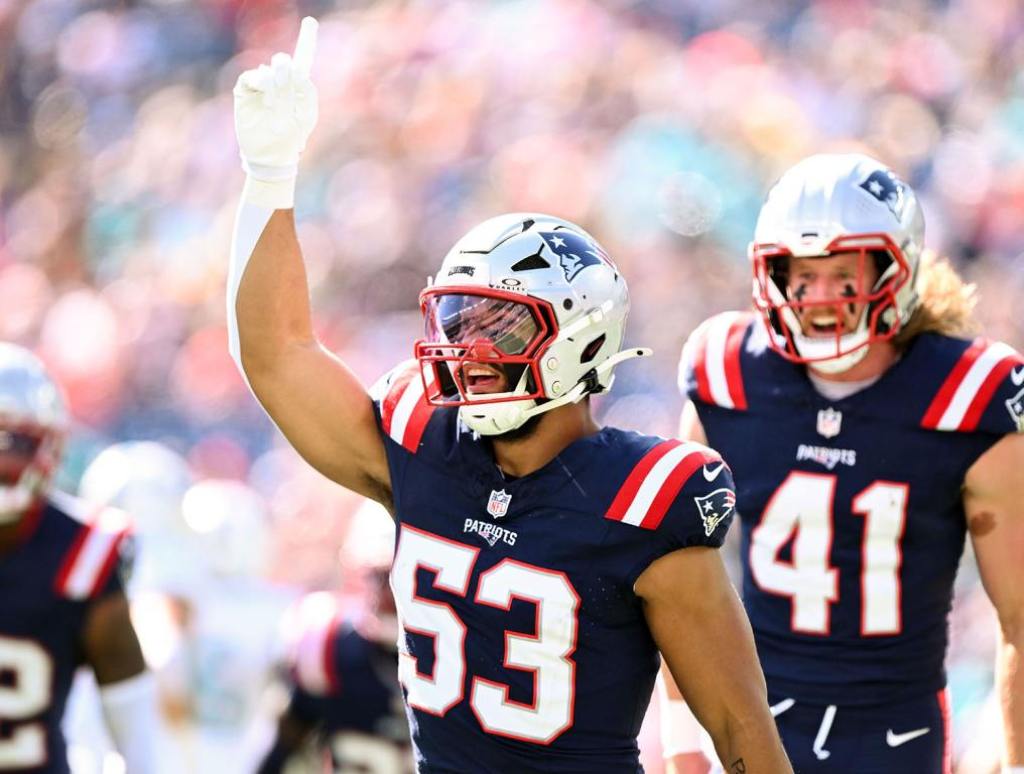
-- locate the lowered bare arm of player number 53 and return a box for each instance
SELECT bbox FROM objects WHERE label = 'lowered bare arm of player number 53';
[636,548,793,774]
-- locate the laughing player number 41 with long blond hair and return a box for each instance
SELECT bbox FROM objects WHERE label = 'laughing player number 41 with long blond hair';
[666,155,1024,774]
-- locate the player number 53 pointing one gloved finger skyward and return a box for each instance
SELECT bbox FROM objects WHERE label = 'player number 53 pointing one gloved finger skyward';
[227,18,791,774]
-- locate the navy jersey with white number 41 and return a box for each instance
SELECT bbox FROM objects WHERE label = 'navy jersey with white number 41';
[680,313,1024,704]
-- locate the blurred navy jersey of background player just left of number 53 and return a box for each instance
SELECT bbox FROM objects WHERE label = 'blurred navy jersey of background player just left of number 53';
[289,592,413,774]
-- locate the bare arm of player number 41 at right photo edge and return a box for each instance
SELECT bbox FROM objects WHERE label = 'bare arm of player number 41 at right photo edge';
[964,434,1024,770]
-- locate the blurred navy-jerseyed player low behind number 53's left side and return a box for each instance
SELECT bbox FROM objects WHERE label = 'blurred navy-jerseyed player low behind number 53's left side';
[259,500,413,774]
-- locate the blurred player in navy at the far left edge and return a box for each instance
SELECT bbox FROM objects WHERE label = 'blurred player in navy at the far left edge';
[0,343,157,772]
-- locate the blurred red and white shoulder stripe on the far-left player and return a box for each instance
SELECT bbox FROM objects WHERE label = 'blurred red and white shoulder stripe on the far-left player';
[54,509,129,599]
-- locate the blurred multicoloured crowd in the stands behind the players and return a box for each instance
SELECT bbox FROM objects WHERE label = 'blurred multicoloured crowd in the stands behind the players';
[0,0,1024,774]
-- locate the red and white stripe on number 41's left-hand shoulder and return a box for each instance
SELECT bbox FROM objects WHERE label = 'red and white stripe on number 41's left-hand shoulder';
[682,312,751,411]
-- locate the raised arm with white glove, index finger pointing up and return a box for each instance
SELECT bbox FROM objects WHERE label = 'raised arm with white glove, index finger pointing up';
[227,17,390,505]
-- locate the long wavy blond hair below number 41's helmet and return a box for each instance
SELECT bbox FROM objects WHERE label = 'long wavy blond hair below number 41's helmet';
[893,250,978,350]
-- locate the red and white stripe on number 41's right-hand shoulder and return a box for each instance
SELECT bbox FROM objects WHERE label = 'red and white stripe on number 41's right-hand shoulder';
[921,339,1024,432]
